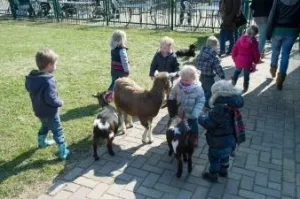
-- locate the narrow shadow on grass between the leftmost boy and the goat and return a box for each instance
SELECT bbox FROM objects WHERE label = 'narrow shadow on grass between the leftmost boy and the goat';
[61,104,99,122]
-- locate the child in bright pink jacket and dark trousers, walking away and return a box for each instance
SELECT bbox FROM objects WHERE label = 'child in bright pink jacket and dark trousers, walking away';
[232,25,260,93]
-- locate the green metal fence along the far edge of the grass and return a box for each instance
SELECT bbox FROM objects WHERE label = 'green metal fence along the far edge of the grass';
[0,0,251,31]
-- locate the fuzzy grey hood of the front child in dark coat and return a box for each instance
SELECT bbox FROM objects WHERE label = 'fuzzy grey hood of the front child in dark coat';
[209,80,243,108]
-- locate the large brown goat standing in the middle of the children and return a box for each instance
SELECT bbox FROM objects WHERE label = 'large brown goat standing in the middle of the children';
[114,72,176,143]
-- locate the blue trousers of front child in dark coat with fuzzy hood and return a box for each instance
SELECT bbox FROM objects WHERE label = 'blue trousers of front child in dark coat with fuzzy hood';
[208,147,232,173]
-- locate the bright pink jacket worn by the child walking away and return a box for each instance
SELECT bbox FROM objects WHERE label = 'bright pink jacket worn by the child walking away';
[232,35,260,69]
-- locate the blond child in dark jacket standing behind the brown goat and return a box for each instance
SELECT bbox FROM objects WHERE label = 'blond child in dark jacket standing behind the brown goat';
[149,37,179,80]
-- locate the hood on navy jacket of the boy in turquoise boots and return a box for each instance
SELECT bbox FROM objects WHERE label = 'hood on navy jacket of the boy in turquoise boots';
[25,70,53,93]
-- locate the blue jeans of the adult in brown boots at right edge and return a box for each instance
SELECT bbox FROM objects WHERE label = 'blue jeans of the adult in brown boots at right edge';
[271,36,297,74]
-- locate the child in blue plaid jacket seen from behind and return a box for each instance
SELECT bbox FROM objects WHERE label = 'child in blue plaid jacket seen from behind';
[196,36,225,108]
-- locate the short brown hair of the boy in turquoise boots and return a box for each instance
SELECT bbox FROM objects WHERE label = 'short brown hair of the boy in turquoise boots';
[35,48,58,70]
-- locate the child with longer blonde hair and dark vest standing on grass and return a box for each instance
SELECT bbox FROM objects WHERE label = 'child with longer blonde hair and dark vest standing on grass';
[108,30,130,92]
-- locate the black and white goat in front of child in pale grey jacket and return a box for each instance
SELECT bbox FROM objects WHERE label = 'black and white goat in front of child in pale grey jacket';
[166,100,194,178]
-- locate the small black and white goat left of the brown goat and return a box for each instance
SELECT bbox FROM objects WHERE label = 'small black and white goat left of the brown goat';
[93,92,119,160]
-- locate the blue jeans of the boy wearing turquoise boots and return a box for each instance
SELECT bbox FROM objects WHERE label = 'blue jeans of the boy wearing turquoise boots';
[38,114,65,144]
